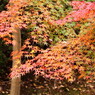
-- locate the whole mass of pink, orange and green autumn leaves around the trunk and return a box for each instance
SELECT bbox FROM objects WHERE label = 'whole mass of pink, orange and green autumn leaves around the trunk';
[0,0,95,82]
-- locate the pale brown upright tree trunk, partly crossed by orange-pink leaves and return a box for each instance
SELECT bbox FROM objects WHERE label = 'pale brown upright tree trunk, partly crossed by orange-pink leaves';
[10,27,21,95]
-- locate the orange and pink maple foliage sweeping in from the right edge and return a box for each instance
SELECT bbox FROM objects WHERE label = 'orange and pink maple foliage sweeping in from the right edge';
[12,1,95,81]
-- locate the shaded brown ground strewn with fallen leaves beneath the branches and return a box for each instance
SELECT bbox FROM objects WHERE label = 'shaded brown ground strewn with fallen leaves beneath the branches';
[0,75,95,95]
